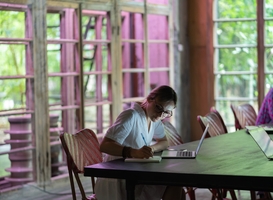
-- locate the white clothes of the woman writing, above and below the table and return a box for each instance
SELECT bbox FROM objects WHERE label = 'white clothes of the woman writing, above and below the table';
[95,103,166,200]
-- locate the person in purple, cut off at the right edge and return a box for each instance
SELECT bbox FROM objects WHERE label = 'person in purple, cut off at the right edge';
[256,88,273,125]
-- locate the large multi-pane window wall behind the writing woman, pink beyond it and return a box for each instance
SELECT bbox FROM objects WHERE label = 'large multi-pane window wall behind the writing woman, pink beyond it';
[0,0,173,189]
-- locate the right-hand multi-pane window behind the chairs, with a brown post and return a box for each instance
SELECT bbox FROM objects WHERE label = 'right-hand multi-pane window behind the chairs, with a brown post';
[214,0,273,131]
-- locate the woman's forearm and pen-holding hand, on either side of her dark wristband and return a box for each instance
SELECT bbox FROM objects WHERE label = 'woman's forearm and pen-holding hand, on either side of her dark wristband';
[100,137,153,158]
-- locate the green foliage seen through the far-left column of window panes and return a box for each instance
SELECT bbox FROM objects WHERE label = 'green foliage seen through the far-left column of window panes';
[0,11,26,109]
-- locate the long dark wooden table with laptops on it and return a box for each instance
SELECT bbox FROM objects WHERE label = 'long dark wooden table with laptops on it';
[84,130,273,200]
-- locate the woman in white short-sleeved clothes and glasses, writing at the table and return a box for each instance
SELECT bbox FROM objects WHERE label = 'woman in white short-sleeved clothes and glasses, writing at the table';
[95,85,185,200]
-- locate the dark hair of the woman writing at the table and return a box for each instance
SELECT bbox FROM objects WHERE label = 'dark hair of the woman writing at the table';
[147,85,177,105]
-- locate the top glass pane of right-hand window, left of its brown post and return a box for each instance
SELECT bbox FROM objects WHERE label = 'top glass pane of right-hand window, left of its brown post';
[216,0,256,19]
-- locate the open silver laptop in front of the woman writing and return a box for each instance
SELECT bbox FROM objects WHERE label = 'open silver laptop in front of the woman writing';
[161,124,209,159]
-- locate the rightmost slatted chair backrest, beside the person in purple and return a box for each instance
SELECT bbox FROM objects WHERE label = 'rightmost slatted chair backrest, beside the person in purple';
[230,103,257,130]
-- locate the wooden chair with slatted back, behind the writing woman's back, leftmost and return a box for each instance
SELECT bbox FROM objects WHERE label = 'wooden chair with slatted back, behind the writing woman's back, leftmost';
[60,129,102,200]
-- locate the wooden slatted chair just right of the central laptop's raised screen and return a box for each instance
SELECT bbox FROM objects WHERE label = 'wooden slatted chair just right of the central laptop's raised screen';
[197,107,237,200]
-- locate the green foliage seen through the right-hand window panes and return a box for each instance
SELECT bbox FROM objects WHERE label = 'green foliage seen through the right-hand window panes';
[214,0,273,130]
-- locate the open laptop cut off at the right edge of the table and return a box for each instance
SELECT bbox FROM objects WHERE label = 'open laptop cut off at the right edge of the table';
[248,127,273,160]
